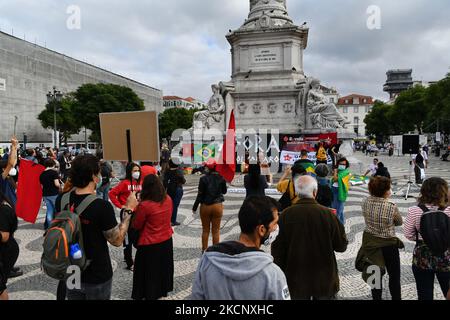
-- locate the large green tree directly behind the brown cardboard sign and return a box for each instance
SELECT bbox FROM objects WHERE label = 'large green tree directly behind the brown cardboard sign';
[72,83,145,142]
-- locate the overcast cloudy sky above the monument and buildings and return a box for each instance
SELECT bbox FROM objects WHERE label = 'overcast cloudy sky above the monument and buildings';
[0,0,450,101]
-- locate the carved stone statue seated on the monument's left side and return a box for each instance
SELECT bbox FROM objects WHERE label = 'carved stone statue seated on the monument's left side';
[194,84,226,130]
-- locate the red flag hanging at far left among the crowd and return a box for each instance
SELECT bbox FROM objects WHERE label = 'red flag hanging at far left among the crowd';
[16,160,45,223]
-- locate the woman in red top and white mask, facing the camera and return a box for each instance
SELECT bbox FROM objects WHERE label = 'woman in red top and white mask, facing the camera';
[109,162,142,270]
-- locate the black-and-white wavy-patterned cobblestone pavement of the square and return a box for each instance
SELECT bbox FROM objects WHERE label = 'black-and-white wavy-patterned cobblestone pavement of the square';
[8,153,450,300]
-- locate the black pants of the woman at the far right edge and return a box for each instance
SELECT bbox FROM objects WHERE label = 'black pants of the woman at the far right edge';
[413,266,450,301]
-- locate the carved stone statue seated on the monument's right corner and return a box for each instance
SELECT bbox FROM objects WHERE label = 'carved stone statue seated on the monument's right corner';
[304,78,350,129]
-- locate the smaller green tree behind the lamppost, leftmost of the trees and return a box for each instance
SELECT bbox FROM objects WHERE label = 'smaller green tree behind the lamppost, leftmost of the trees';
[38,94,81,143]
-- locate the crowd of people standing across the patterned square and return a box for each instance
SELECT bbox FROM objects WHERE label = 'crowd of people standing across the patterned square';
[0,139,450,300]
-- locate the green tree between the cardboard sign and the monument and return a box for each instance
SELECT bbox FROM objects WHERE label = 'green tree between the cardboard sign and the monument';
[159,108,199,140]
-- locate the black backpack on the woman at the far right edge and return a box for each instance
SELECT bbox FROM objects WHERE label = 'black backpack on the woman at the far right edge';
[417,205,450,257]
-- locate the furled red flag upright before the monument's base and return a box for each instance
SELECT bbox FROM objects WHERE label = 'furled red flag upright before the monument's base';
[216,111,236,183]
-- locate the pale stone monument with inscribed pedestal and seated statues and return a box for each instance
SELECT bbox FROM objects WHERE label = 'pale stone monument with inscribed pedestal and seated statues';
[195,0,354,156]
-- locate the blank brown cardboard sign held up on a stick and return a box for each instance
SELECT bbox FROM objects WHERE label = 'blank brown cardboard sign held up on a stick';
[100,111,160,162]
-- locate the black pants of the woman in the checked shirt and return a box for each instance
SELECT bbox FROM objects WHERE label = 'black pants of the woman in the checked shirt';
[372,246,402,300]
